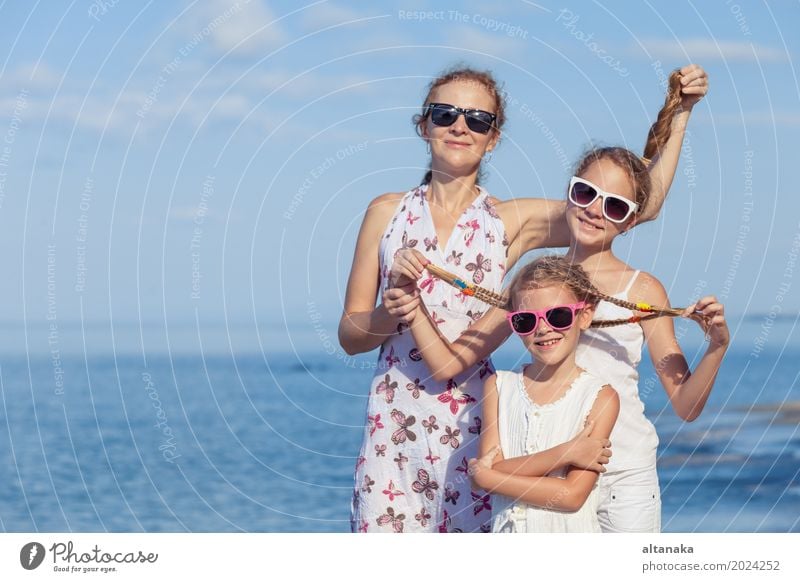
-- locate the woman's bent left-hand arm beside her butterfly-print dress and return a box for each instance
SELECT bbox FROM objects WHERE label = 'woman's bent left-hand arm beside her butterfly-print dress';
[339,193,412,355]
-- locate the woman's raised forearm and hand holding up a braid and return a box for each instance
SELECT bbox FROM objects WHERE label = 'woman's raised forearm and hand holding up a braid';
[637,65,708,223]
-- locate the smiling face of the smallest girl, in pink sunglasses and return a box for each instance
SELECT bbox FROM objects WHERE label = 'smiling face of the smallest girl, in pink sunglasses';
[514,284,593,365]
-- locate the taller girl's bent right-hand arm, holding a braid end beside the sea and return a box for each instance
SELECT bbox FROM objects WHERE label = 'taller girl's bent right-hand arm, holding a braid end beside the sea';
[633,273,730,421]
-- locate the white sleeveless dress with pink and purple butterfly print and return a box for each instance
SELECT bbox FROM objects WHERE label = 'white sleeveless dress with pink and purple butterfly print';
[351,186,508,532]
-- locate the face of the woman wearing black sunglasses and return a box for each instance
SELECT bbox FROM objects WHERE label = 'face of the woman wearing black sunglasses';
[422,80,499,176]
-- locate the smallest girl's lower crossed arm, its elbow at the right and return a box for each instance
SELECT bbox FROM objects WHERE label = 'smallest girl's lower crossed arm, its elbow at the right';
[470,386,619,512]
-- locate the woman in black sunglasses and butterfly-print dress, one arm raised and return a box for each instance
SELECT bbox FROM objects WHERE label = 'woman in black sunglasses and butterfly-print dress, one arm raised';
[339,66,706,532]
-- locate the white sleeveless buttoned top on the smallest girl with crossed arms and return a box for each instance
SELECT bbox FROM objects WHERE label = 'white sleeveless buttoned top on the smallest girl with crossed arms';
[492,371,607,533]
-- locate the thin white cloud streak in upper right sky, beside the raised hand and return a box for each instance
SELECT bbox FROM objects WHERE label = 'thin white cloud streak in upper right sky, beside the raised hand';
[631,38,788,63]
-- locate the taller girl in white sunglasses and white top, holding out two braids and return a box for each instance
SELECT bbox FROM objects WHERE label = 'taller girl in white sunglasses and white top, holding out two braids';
[386,113,730,532]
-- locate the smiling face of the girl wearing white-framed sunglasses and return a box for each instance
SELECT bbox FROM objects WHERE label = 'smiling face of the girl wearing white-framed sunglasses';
[567,159,636,248]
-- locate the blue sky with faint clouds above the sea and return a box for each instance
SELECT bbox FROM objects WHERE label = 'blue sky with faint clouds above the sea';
[0,0,800,356]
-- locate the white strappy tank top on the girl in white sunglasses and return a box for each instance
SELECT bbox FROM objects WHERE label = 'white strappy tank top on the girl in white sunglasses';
[575,271,658,474]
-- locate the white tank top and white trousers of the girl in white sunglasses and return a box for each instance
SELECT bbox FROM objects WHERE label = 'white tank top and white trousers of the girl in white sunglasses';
[575,271,661,532]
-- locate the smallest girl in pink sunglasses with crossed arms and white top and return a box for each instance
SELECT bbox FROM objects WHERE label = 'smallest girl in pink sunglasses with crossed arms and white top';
[470,257,619,533]
